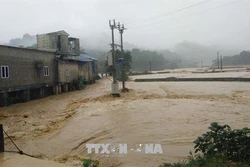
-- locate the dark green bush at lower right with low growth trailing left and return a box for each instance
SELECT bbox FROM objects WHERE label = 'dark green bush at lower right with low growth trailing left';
[160,122,250,167]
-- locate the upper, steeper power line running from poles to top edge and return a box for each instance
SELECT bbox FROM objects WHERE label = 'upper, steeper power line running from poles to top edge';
[127,0,211,25]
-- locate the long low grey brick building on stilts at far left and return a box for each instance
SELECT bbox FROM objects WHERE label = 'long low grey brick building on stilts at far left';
[0,45,57,106]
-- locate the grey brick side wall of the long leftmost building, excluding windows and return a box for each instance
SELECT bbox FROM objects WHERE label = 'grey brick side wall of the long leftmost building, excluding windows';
[0,46,57,92]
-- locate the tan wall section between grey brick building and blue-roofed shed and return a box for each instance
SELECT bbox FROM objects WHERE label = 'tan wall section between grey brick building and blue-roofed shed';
[58,60,78,84]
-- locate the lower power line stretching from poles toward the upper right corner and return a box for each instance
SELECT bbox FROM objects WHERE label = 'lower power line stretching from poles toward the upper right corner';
[130,0,241,29]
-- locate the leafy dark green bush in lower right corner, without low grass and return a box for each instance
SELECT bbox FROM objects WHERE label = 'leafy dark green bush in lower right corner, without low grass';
[194,122,250,162]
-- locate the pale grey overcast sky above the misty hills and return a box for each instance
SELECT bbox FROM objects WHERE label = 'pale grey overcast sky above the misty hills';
[0,0,250,50]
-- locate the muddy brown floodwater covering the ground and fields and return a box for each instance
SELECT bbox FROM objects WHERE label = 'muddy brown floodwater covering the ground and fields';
[0,76,250,167]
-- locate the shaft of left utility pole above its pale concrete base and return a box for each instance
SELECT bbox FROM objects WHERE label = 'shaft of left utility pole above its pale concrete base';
[109,20,117,83]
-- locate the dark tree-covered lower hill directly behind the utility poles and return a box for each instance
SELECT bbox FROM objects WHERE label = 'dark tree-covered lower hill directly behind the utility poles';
[84,49,197,73]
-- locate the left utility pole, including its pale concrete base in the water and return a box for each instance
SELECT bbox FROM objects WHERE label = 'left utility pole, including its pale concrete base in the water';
[109,20,120,97]
